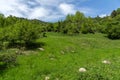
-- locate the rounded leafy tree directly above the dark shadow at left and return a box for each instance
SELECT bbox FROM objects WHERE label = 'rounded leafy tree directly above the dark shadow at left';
[13,21,40,45]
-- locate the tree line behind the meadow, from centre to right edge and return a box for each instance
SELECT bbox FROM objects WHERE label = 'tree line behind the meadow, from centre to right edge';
[46,8,120,39]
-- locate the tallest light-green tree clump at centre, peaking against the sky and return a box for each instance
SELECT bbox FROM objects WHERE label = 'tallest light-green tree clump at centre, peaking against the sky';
[54,11,85,35]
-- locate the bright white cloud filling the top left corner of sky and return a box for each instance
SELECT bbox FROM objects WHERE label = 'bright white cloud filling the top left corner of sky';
[0,0,28,17]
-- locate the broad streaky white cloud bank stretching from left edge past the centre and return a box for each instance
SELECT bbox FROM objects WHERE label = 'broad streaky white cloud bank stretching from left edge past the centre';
[0,0,94,21]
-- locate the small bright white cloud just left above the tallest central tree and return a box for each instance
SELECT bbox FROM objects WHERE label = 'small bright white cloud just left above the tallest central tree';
[59,3,75,15]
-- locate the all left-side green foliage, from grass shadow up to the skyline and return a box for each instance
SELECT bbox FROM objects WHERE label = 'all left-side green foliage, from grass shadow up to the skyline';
[0,16,44,49]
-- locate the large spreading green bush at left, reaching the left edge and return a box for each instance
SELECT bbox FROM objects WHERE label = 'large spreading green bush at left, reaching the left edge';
[0,20,42,49]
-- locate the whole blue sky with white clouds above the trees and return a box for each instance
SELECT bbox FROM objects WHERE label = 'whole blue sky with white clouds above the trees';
[0,0,120,22]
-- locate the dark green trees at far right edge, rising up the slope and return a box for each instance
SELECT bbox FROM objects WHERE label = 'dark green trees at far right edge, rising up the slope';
[106,8,120,39]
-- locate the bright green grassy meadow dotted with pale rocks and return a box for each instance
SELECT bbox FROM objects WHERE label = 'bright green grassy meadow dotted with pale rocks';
[0,33,120,80]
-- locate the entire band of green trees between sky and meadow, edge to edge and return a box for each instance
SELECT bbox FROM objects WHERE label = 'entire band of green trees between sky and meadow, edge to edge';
[0,8,120,48]
